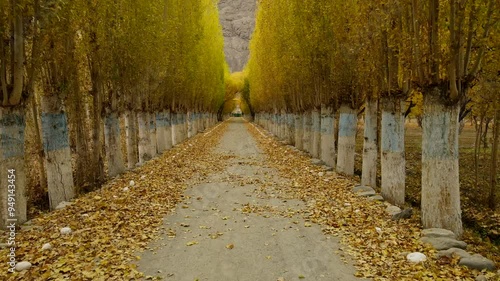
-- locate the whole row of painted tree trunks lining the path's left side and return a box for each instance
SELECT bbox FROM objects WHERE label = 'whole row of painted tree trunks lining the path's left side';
[0,107,216,226]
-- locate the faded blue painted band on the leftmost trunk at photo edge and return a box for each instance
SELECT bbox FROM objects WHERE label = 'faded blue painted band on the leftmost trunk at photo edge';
[0,114,26,159]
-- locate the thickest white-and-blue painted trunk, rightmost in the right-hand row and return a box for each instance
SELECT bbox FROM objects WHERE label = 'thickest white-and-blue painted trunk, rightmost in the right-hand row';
[421,93,463,236]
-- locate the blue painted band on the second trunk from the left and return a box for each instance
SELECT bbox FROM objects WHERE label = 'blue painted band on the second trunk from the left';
[42,113,69,152]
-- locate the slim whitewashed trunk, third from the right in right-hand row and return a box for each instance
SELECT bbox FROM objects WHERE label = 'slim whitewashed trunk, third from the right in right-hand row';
[361,100,378,188]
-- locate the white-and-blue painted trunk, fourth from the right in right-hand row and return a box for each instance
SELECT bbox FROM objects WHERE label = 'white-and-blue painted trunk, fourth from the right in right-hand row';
[336,104,358,175]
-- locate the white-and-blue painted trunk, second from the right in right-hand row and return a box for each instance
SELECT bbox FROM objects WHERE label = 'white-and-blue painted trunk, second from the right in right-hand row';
[380,97,406,206]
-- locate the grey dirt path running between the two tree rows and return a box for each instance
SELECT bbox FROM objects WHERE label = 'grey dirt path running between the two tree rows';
[138,119,359,281]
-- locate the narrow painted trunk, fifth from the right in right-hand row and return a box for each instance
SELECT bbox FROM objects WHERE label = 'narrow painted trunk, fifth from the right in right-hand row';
[321,106,337,168]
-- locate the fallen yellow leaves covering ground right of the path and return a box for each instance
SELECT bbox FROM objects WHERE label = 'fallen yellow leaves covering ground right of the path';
[246,124,494,280]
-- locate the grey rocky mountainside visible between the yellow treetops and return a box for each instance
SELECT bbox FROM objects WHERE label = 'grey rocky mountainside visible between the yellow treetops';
[219,0,257,72]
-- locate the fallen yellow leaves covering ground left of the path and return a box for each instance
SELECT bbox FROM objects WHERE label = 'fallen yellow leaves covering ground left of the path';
[0,123,227,281]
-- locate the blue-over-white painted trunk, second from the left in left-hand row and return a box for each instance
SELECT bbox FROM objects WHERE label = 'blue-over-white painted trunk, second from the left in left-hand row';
[41,96,75,209]
